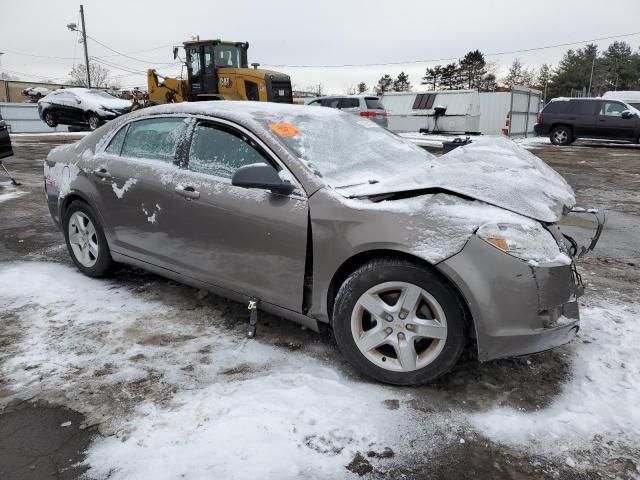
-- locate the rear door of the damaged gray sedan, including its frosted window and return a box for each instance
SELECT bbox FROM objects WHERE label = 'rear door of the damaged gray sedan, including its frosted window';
[91,116,190,268]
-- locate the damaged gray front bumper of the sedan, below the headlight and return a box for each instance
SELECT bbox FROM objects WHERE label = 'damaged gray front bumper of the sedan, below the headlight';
[437,236,584,361]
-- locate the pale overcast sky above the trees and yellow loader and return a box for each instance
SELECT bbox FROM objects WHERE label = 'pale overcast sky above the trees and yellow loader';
[0,0,640,93]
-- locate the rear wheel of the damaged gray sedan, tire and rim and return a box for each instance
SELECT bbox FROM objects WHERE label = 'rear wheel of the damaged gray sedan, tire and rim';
[62,200,113,278]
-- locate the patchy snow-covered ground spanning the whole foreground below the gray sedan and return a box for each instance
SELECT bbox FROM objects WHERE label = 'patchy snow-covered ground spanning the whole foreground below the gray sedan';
[0,262,640,480]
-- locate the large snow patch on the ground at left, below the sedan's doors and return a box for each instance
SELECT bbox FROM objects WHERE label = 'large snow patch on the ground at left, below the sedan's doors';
[0,263,411,480]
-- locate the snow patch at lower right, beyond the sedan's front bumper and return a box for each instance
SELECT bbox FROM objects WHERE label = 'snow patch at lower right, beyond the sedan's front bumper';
[470,302,640,454]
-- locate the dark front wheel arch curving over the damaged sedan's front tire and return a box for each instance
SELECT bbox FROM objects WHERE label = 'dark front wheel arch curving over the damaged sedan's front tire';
[327,249,475,332]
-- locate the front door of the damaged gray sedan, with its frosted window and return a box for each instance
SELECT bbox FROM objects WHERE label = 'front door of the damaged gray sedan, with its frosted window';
[157,121,308,312]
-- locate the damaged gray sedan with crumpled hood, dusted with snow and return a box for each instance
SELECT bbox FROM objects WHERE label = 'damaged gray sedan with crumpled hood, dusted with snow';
[44,101,595,385]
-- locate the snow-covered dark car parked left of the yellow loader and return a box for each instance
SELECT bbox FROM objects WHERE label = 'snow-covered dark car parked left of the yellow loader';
[38,88,131,130]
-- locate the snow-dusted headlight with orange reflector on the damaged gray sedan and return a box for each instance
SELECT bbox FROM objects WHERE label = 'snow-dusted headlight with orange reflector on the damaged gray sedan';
[476,222,571,265]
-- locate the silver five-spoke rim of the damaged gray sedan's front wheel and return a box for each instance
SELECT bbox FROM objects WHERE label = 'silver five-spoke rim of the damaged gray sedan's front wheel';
[351,282,447,372]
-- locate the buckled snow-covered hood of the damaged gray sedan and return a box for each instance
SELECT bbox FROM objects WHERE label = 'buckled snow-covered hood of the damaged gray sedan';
[340,137,575,223]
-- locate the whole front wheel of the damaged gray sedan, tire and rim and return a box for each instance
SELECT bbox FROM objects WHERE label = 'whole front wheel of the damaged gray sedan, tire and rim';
[333,258,467,385]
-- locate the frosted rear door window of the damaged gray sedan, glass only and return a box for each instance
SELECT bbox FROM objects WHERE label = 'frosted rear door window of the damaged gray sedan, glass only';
[122,118,187,162]
